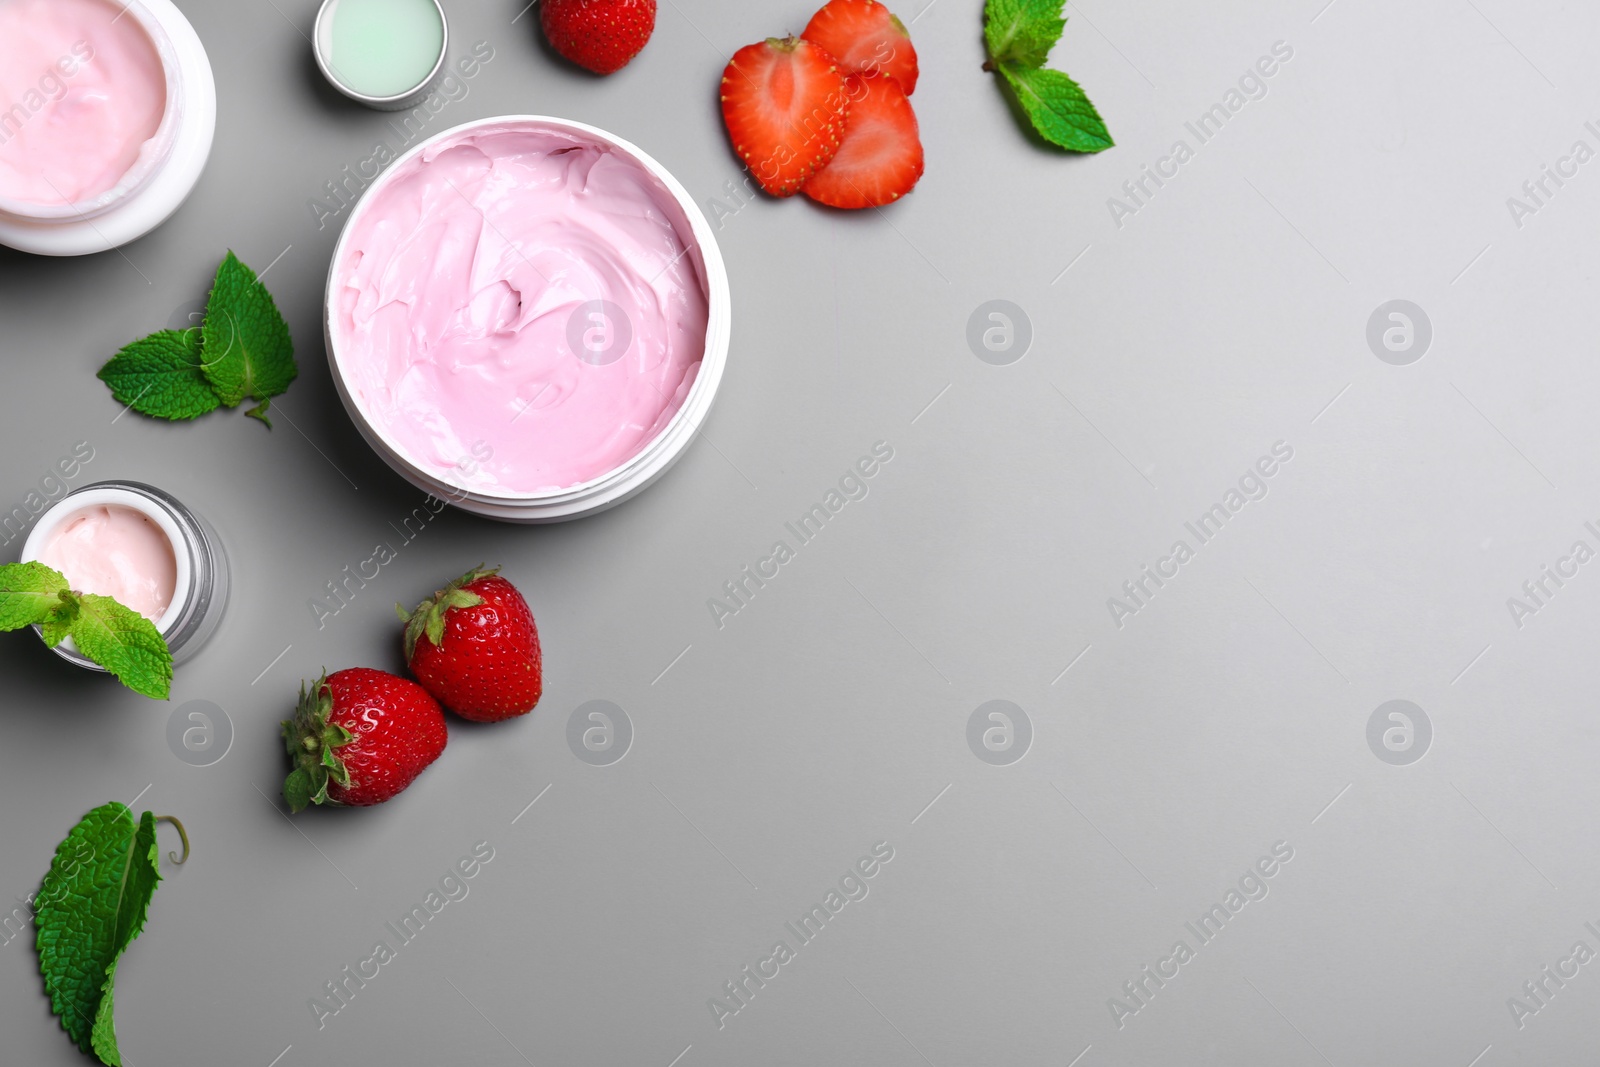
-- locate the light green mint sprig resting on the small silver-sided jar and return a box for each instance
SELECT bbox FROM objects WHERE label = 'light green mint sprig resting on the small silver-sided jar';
[0,561,173,701]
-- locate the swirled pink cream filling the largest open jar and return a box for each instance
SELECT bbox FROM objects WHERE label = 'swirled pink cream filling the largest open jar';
[330,123,707,496]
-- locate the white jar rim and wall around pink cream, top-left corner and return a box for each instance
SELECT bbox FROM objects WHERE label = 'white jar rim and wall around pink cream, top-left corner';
[0,0,216,256]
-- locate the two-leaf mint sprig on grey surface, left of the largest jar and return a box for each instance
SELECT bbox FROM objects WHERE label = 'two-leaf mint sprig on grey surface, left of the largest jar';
[98,251,299,427]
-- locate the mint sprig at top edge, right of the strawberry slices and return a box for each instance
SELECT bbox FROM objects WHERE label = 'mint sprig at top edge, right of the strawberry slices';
[984,0,1115,152]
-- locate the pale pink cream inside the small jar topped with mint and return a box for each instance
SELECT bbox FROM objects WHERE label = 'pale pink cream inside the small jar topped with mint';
[38,504,178,622]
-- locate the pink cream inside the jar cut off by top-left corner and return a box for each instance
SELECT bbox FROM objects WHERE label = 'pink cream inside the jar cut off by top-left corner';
[0,0,166,205]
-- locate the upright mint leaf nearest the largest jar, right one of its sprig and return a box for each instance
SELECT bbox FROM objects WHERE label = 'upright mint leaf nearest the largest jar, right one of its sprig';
[200,251,299,421]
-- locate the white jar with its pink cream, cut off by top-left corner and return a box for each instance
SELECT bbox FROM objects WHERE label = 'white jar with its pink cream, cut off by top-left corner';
[0,0,216,256]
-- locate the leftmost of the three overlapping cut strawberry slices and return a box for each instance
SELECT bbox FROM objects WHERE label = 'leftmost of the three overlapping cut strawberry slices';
[722,37,850,197]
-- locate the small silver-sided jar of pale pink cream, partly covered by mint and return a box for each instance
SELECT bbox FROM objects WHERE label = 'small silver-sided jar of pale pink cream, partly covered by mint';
[22,482,229,670]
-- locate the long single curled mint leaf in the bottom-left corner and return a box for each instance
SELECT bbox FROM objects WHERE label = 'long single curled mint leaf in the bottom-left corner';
[35,803,162,1067]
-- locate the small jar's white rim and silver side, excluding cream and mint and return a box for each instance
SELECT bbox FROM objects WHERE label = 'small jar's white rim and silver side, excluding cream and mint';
[21,482,229,670]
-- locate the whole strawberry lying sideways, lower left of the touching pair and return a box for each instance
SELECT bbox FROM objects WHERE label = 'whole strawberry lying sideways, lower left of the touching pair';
[283,667,446,811]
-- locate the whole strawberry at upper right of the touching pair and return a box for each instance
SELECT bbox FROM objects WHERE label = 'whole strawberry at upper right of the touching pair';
[397,568,544,723]
